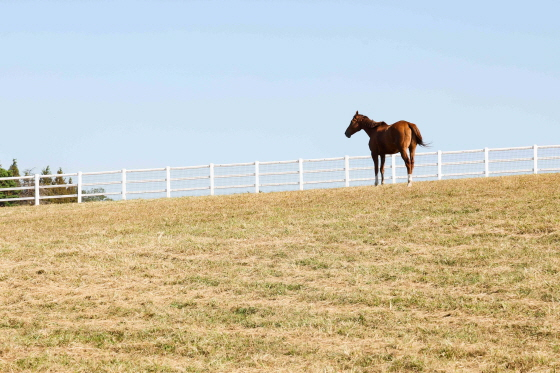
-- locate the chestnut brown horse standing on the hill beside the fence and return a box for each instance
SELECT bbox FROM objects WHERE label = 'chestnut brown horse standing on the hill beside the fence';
[344,111,428,186]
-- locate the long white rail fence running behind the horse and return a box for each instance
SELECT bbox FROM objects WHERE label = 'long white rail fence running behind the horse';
[0,145,560,205]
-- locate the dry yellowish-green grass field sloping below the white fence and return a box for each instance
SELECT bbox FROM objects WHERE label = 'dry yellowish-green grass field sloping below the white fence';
[0,174,560,372]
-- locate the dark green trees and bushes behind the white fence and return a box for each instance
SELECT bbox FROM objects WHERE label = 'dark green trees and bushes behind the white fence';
[0,159,110,206]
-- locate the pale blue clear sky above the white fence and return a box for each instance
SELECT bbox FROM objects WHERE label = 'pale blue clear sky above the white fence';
[0,0,560,172]
